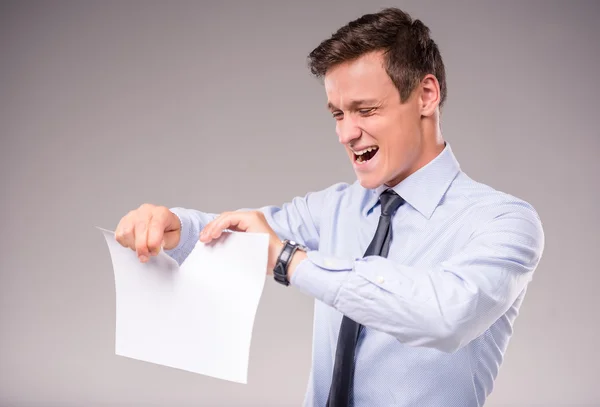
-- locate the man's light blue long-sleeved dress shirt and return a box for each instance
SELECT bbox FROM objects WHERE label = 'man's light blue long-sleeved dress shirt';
[167,143,544,407]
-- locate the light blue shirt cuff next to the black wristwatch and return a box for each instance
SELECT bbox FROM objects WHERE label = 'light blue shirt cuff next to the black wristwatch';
[290,250,354,307]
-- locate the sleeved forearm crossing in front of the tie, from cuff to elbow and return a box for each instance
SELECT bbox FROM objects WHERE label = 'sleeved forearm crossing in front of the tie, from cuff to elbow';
[289,252,531,352]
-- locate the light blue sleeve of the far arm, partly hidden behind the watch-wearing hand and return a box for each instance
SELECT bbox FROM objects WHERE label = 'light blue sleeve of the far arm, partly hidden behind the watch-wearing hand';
[165,183,349,264]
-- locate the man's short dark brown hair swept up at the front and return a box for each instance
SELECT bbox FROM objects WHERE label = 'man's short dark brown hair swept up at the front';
[308,8,447,107]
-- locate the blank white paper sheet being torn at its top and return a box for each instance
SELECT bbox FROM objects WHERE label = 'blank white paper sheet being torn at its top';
[98,227,269,383]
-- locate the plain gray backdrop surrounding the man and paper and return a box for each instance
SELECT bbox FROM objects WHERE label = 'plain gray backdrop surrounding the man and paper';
[0,1,600,407]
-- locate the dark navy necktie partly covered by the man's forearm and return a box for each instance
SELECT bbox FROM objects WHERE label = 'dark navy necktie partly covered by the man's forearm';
[327,189,404,407]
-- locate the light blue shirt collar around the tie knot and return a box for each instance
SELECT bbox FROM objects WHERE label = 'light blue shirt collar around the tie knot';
[365,142,460,219]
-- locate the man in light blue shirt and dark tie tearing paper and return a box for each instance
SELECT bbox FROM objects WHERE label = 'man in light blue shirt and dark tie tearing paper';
[115,9,544,407]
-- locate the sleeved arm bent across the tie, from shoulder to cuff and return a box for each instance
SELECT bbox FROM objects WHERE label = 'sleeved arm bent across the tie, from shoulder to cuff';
[289,204,544,352]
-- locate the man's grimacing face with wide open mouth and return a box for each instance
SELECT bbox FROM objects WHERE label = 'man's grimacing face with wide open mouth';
[325,52,423,189]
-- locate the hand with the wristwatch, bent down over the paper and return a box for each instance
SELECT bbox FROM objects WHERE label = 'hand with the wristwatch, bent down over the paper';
[200,211,283,274]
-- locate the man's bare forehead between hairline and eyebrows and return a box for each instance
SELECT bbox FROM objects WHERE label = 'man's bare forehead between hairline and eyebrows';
[324,52,395,107]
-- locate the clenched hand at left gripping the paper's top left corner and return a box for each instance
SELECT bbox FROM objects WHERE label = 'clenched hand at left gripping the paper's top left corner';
[115,204,181,263]
